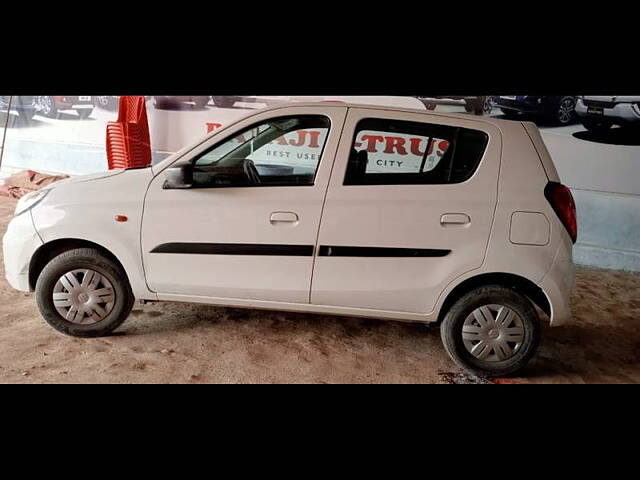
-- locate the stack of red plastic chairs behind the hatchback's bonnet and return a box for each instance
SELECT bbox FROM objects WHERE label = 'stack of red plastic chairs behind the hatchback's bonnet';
[106,96,151,170]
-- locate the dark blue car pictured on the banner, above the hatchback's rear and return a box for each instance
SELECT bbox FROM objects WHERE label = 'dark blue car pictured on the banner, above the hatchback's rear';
[493,95,577,125]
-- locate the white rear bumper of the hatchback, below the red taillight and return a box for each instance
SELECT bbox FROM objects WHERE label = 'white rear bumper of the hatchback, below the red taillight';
[540,239,576,327]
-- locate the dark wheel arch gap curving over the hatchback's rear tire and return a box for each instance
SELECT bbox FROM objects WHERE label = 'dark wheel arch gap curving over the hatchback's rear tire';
[438,272,551,323]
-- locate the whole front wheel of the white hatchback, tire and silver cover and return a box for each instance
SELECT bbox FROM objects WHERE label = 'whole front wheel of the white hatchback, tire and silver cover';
[36,248,134,337]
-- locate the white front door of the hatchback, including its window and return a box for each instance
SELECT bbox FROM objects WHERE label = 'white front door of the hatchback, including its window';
[142,106,347,303]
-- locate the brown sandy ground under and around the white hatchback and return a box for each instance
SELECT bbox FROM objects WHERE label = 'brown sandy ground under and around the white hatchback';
[0,198,640,383]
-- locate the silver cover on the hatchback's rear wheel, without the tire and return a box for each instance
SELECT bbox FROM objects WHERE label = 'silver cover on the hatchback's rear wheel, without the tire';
[462,305,524,362]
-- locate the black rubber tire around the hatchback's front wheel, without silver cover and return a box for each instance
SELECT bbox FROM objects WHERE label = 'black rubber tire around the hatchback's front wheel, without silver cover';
[36,248,135,337]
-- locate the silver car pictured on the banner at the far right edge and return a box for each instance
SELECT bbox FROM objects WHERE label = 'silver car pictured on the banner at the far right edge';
[576,95,640,131]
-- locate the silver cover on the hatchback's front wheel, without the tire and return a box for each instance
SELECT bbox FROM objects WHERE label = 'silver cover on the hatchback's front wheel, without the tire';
[53,269,116,325]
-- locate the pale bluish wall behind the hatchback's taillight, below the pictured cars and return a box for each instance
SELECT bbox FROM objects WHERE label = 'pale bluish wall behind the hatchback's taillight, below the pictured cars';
[542,127,640,271]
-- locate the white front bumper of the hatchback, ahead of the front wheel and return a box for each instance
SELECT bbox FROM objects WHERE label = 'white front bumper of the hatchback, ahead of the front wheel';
[2,211,43,292]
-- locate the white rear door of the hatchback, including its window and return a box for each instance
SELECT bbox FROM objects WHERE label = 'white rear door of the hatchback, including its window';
[311,108,501,313]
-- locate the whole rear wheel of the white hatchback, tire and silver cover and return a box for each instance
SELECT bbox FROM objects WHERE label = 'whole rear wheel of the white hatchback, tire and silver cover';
[440,285,541,376]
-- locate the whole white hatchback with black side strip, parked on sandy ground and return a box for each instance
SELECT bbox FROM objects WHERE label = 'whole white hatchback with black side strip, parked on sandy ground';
[3,102,576,375]
